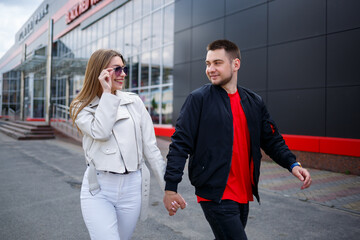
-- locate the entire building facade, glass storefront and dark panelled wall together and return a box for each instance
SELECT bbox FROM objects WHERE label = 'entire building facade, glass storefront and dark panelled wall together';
[0,0,360,139]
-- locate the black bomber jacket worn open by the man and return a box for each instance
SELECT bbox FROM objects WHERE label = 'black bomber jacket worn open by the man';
[164,83,296,202]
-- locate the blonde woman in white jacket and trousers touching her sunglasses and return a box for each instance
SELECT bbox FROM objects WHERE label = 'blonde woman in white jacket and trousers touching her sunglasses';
[70,49,165,240]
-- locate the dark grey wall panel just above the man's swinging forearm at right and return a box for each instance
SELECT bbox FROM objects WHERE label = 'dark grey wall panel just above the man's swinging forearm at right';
[268,89,325,136]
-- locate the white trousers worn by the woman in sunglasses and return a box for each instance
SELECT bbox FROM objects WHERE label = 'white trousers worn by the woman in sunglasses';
[80,167,141,240]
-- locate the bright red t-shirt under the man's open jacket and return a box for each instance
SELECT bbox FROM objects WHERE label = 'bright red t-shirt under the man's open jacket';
[197,92,254,203]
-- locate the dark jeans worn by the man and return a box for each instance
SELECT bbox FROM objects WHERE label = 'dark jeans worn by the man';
[200,200,249,240]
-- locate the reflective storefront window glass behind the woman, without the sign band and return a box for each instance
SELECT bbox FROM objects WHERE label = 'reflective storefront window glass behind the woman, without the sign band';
[2,0,174,124]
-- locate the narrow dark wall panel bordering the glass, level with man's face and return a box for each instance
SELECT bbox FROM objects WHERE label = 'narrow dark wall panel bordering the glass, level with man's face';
[173,63,191,97]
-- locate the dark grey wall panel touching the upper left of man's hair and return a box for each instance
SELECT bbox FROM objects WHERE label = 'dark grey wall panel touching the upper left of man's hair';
[191,19,224,60]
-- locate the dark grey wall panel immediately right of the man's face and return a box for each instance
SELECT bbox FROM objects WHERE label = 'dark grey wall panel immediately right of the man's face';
[238,48,267,91]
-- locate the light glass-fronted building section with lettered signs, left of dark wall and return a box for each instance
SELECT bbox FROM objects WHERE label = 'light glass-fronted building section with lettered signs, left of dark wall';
[0,0,174,125]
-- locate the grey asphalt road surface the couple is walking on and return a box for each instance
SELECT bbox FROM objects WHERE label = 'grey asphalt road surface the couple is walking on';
[0,133,360,240]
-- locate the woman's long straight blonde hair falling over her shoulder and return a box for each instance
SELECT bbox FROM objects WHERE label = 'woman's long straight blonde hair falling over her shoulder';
[69,49,125,132]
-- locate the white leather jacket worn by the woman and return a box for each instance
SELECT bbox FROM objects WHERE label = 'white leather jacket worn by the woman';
[75,91,165,220]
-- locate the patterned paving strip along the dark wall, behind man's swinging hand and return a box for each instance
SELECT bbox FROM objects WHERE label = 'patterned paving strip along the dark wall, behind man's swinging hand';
[158,139,360,215]
